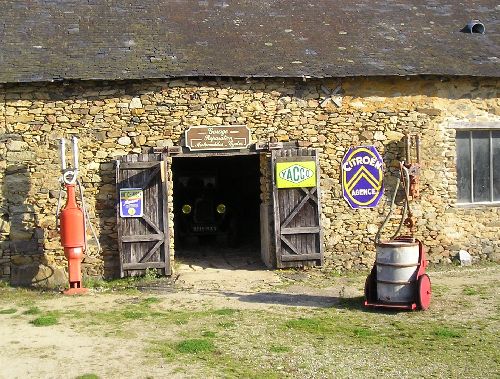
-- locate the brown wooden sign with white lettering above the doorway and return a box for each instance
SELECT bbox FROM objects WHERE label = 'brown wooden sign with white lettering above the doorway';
[185,125,250,151]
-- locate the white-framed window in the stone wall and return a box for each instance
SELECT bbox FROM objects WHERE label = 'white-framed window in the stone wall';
[456,129,500,204]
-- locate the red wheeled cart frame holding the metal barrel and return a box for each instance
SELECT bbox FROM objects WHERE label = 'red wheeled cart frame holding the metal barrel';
[364,240,431,310]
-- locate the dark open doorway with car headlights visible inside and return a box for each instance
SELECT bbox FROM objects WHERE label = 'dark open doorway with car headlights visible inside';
[172,154,260,258]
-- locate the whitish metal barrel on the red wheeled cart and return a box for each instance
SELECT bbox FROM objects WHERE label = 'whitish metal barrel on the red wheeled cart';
[375,241,420,303]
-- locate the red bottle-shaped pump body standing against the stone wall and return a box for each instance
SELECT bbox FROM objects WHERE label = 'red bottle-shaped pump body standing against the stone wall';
[59,184,88,295]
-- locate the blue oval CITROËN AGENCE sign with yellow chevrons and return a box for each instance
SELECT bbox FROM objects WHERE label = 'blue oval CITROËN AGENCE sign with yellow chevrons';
[342,146,384,209]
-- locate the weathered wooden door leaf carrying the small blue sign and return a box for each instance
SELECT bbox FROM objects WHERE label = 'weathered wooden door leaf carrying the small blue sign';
[116,154,171,277]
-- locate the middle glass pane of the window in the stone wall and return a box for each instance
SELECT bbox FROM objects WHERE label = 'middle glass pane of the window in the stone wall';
[472,131,491,202]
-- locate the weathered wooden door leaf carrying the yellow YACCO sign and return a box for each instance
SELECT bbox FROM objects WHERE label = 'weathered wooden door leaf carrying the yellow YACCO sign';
[271,148,323,268]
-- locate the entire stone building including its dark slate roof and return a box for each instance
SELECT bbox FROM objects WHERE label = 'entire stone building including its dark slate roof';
[0,0,500,284]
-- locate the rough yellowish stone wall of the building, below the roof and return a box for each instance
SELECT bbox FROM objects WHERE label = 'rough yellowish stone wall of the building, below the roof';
[0,78,500,284]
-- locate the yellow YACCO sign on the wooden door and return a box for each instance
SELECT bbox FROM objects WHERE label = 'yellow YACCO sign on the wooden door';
[276,161,316,188]
